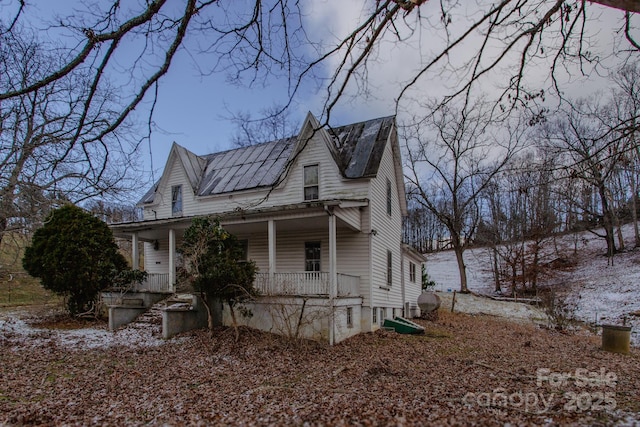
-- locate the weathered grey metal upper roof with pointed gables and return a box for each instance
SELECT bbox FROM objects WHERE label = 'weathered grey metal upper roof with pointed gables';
[139,114,395,204]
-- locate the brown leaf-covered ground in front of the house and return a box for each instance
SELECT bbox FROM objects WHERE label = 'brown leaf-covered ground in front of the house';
[0,310,640,425]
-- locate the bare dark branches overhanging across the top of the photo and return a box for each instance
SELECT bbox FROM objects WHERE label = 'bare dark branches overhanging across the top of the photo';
[0,0,640,144]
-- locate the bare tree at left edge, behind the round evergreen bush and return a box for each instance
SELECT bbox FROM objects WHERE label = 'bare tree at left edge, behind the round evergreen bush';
[0,30,141,246]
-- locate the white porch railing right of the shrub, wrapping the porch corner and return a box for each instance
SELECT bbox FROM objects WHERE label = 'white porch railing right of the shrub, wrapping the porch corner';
[255,271,360,297]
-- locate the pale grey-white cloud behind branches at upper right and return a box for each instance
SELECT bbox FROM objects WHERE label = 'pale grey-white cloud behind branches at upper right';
[298,0,622,125]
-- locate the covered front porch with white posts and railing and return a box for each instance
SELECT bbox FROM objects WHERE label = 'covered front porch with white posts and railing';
[111,201,369,298]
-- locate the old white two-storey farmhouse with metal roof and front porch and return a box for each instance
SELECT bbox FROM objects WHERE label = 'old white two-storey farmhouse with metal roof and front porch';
[112,114,424,343]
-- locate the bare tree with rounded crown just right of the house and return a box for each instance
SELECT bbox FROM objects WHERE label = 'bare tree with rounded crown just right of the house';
[406,101,522,292]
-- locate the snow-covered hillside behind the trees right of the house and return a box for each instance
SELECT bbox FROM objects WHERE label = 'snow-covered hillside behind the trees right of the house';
[426,225,640,346]
